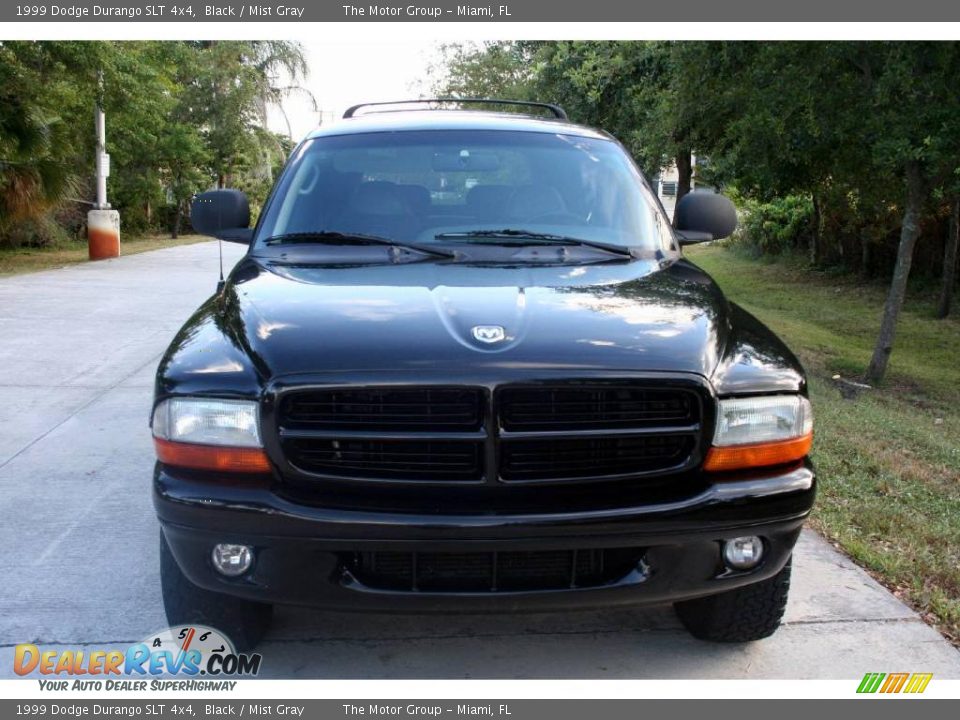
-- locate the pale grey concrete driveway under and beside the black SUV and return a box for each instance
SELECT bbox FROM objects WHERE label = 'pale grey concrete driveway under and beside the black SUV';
[0,243,960,679]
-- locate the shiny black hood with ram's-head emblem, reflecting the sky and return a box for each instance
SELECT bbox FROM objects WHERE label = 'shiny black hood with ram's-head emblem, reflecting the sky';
[218,257,729,379]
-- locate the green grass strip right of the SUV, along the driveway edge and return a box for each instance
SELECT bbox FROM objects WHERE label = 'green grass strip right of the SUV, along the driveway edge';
[687,246,960,644]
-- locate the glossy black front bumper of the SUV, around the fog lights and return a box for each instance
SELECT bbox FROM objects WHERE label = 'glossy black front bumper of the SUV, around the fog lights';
[154,464,816,612]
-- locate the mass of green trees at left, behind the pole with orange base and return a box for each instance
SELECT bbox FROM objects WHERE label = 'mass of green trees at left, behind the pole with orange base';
[0,41,306,244]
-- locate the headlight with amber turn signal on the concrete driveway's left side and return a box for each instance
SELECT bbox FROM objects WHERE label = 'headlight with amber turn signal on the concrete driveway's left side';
[153,398,270,473]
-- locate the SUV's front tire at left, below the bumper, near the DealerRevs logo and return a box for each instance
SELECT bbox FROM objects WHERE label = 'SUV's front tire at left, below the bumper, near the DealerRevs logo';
[160,530,273,652]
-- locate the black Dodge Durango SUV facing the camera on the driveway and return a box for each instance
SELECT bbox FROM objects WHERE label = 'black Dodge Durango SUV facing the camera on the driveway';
[151,104,815,648]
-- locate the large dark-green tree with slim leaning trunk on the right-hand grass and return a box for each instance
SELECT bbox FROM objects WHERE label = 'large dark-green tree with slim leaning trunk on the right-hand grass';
[678,42,960,382]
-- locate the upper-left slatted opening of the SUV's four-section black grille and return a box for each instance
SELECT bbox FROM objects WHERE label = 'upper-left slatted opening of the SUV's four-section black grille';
[280,387,483,430]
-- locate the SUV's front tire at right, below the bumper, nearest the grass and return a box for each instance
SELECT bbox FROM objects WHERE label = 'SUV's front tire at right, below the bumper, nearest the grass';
[674,558,792,642]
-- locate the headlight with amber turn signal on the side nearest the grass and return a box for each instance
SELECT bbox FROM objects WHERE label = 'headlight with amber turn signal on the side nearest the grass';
[704,395,813,471]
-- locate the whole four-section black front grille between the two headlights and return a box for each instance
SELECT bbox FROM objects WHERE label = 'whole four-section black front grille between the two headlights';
[275,379,704,487]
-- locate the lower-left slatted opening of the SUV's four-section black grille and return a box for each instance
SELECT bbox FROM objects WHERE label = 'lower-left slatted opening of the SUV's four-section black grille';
[284,438,483,482]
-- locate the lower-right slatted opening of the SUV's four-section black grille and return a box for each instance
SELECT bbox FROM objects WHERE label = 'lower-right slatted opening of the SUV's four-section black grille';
[500,435,694,481]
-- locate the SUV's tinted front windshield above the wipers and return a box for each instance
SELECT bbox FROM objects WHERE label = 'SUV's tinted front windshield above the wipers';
[257,130,673,251]
